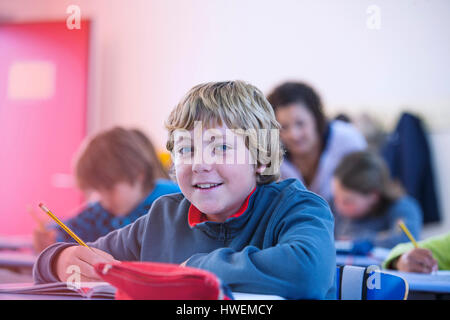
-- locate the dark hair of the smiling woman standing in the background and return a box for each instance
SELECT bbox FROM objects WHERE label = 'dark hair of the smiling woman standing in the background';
[267,82,327,137]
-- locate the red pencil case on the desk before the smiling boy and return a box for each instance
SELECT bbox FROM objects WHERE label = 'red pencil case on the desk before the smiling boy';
[95,261,230,300]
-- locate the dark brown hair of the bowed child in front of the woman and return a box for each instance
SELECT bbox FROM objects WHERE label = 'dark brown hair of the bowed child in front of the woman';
[334,151,404,215]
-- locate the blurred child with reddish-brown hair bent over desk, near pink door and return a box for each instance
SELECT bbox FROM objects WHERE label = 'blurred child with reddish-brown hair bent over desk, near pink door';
[33,127,180,252]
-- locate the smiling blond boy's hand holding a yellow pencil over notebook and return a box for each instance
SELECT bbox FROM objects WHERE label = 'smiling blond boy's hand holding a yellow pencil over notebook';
[55,246,118,282]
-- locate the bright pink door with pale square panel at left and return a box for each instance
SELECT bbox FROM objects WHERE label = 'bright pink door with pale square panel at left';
[0,21,89,235]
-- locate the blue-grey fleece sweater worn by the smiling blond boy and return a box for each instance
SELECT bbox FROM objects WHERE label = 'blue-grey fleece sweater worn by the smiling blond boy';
[33,179,336,299]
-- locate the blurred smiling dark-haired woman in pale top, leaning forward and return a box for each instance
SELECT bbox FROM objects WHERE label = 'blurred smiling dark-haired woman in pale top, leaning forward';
[267,82,367,201]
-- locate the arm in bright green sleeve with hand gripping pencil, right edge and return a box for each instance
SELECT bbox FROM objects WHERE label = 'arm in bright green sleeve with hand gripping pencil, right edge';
[383,232,450,273]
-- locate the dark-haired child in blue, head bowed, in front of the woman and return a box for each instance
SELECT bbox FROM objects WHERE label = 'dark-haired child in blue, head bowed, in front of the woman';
[333,151,422,251]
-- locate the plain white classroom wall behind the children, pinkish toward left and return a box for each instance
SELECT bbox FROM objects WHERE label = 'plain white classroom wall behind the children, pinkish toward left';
[0,0,450,235]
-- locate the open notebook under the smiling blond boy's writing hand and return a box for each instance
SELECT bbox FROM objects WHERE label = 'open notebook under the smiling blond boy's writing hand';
[0,282,116,299]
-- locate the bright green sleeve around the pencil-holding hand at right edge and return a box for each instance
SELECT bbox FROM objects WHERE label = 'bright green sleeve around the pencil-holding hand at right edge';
[383,233,450,270]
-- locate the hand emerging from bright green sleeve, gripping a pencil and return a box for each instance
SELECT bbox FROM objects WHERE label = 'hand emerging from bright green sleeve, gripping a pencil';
[394,248,437,273]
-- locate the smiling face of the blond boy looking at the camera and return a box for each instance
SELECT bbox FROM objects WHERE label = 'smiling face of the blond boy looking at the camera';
[173,125,260,222]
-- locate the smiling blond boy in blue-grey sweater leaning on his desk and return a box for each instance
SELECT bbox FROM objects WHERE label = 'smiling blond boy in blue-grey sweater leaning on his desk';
[33,81,336,299]
